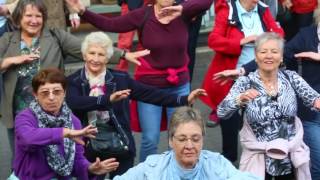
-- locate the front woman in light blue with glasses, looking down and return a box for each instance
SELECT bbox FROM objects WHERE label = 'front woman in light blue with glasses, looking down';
[110,107,260,180]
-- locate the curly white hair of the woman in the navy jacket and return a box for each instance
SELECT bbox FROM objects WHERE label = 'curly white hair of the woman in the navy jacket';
[81,31,113,59]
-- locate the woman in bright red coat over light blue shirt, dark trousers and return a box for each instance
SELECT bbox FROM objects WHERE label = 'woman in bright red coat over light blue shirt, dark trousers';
[202,0,283,162]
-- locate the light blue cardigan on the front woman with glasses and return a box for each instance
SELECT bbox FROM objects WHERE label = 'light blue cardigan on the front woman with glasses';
[114,150,261,180]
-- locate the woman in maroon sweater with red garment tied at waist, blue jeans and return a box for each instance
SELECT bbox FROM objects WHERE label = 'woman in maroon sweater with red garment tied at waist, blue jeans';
[67,0,212,161]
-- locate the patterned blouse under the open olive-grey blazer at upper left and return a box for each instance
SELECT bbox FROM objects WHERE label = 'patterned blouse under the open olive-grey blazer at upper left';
[13,38,40,115]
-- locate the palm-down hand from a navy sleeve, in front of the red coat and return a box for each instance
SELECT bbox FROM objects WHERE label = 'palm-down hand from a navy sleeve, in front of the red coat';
[212,69,240,85]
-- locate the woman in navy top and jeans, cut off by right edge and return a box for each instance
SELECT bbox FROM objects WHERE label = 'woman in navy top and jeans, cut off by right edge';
[216,8,320,179]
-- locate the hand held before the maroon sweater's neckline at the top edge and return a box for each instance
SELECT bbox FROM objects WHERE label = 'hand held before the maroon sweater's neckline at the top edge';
[158,5,183,24]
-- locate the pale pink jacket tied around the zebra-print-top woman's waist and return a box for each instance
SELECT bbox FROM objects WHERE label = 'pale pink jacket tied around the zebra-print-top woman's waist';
[239,117,311,180]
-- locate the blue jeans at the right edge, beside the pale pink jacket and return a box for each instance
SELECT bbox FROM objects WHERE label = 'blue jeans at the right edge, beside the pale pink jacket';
[302,113,320,179]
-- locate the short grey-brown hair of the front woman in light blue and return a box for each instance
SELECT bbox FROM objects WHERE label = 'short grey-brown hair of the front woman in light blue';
[168,106,206,139]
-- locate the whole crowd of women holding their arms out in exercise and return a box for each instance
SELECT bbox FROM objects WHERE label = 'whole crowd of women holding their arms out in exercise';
[0,0,320,180]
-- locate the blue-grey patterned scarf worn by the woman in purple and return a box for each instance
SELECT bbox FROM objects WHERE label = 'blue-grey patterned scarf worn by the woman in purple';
[30,101,75,176]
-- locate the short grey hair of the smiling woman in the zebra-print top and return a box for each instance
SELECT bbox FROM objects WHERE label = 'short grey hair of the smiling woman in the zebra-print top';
[254,32,284,52]
